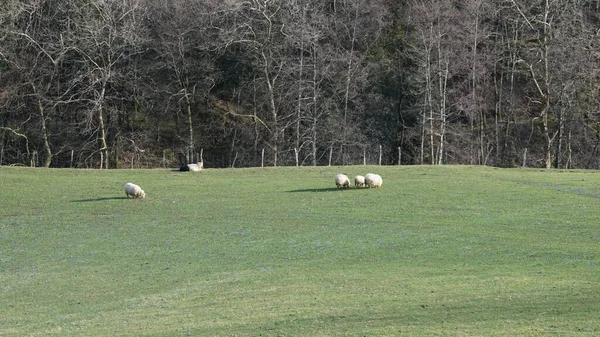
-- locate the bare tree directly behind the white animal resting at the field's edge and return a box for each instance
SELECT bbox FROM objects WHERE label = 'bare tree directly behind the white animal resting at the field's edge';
[145,1,226,162]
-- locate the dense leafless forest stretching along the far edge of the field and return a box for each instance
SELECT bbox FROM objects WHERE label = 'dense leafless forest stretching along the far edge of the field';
[0,0,600,169]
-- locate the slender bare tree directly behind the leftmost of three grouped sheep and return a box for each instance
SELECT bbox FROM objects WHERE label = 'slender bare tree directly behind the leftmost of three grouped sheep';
[326,0,389,164]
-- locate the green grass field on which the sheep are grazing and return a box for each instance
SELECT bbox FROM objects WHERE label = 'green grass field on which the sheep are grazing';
[0,166,600,336]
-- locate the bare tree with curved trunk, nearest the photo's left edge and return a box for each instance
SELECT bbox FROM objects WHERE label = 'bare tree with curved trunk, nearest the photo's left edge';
[3,0,86,167]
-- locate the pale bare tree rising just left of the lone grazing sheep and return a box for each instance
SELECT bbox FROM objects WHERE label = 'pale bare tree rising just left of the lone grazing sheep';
[61,0,145,168]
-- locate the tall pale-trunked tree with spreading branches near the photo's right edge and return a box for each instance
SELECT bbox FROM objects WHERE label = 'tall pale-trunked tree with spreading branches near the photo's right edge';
[496,0,594,168]
